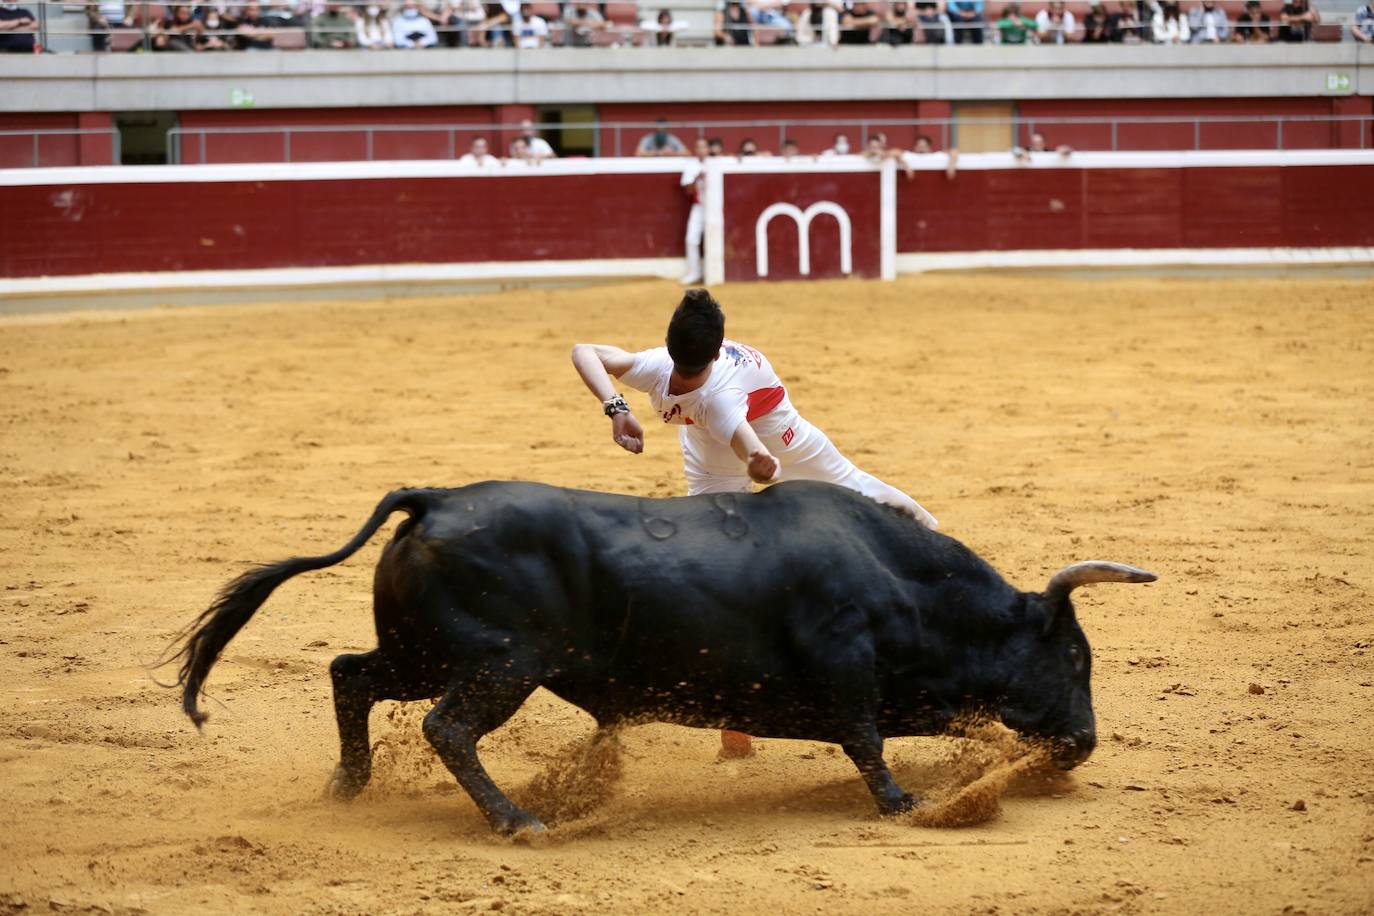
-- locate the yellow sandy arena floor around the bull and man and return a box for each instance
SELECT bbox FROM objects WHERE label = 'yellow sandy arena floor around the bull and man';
[0,276,1374,916]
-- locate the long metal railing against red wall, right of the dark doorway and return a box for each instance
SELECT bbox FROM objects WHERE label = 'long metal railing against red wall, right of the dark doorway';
[166,115,1374,163]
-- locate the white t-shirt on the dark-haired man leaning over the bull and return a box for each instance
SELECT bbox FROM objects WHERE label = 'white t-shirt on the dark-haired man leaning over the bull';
[620,339,793,448]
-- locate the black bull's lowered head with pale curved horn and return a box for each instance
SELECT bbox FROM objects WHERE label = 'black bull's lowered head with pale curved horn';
[1000,560,1157,769]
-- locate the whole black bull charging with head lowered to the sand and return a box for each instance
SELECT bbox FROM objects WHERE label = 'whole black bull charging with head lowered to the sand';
[177,481,1154,834]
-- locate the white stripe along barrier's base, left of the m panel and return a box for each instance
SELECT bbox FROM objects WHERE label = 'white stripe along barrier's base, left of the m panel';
[0,258,687,297]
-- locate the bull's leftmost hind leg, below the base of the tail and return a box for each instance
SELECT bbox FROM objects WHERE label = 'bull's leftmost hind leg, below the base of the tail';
[324,650,434,801]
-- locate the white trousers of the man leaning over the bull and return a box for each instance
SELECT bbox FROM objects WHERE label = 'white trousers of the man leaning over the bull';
[677,409,938,529]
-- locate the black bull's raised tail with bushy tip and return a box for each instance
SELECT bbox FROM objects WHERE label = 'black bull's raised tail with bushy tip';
[166,490,429,728]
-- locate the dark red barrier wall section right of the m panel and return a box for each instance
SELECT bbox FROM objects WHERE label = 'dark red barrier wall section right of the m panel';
[897,165,1374,251]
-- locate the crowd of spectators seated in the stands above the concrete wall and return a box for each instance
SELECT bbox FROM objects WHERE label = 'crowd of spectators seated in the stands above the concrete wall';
[0,0,1352,52]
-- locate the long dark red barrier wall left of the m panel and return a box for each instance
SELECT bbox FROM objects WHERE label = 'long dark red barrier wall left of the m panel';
[0,174,688,277]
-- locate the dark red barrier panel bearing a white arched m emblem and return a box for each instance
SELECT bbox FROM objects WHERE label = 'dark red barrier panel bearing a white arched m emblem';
[724,172,882,280]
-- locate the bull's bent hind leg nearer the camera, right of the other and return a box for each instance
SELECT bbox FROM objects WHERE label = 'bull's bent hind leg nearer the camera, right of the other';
[425,655,544,836]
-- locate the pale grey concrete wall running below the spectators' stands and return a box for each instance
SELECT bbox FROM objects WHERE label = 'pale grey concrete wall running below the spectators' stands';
[0,43,1374,111]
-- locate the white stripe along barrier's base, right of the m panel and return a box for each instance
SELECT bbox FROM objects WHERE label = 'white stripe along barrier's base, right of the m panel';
[896,247,1374,273]
